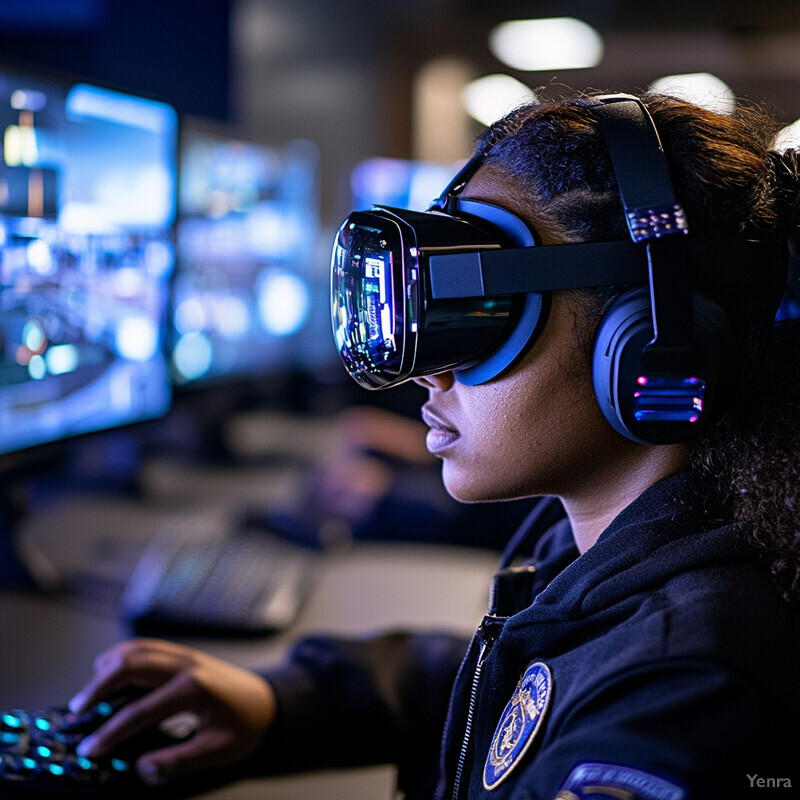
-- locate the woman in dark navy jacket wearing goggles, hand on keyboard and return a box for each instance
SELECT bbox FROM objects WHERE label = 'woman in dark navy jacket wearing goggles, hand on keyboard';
[72,96,800,800]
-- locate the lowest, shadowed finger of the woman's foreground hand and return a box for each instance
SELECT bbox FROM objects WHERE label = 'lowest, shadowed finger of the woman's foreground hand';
[136,729,240,785]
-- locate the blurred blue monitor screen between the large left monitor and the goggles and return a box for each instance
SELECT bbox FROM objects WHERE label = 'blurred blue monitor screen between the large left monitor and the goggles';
[170,121,320,386]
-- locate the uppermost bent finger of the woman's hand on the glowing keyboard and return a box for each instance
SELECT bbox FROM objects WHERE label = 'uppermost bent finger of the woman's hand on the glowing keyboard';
[69,639,192,714]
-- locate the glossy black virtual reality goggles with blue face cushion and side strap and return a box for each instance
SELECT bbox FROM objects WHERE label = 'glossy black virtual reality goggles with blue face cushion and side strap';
[332,200,772,382]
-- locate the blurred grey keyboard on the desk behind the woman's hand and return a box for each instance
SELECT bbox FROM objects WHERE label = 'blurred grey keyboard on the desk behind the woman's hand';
[120,527,320,636]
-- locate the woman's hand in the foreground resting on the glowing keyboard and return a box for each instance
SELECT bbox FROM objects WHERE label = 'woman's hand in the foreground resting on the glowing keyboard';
[70,639,275,784]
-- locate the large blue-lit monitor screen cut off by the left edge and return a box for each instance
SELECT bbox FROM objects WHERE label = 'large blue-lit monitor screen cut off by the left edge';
[0,67,177,453]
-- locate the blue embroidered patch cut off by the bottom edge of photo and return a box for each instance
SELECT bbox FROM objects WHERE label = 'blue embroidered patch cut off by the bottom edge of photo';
[556,764,686,800]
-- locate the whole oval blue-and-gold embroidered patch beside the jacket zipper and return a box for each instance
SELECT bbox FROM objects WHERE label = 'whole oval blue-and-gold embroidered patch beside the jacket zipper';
[483,661,553,789]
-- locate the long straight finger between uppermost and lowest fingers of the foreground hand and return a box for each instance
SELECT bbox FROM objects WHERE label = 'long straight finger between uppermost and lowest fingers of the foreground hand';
[78,675,198,758]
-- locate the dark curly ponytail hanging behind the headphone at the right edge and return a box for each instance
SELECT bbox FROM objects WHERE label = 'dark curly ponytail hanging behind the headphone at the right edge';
[694,150,800,605]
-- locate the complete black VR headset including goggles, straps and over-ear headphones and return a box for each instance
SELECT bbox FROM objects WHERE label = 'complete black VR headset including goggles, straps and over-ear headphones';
[331,95,786,443]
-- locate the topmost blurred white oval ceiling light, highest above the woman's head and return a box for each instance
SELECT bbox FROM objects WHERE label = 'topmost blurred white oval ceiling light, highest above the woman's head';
[489,17,603,70]
